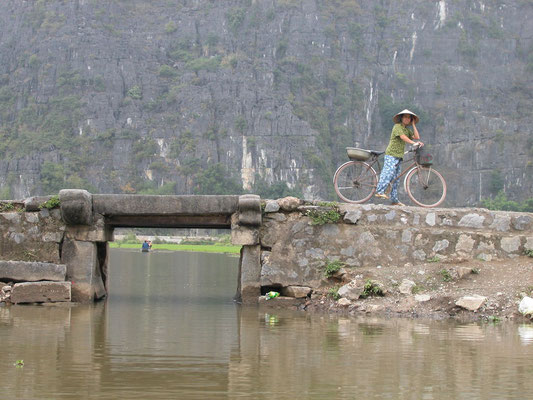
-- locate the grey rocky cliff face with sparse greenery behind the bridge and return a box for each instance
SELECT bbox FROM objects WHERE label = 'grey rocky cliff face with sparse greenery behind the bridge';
[0,0,533,206]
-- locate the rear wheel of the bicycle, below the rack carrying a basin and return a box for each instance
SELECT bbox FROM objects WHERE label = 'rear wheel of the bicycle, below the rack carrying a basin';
[333,161,378,203]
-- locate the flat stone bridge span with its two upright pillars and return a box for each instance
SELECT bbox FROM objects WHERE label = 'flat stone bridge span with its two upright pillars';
[59,193,262,302]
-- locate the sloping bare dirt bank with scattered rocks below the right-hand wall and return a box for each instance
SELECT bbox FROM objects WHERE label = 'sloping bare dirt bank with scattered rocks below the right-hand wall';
[304,256,533,320]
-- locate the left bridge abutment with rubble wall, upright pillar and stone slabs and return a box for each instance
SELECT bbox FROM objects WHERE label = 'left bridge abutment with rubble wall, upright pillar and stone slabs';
[0,191,111,303]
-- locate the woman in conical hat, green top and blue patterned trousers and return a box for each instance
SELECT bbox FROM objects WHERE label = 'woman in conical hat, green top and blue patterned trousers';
[376,109,424,206]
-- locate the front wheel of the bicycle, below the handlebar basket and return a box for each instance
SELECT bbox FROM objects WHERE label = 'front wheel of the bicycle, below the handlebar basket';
[405,167,446,207]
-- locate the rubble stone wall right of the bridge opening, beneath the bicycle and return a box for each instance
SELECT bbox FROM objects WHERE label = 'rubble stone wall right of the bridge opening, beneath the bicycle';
[260,199,533,288]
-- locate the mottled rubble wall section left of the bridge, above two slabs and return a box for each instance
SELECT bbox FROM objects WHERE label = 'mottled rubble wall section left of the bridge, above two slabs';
[0,209,65,264]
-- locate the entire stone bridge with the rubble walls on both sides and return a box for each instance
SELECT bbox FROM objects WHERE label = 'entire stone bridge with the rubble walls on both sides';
[0,189,533,303]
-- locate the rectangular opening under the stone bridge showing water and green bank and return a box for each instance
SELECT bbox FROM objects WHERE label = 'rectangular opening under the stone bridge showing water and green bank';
[106,227,240,303]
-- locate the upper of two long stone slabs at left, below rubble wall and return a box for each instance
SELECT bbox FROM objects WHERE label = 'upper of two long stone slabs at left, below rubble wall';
[0,261,67,282]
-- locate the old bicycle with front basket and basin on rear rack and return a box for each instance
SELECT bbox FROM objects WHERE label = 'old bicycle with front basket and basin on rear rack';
[333,145,446,208]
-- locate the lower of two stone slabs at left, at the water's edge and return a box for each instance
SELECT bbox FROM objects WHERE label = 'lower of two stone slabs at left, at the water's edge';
[11,282,71,304]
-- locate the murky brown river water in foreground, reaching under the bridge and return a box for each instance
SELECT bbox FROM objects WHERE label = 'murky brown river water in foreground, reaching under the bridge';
[0,250,533,400]
